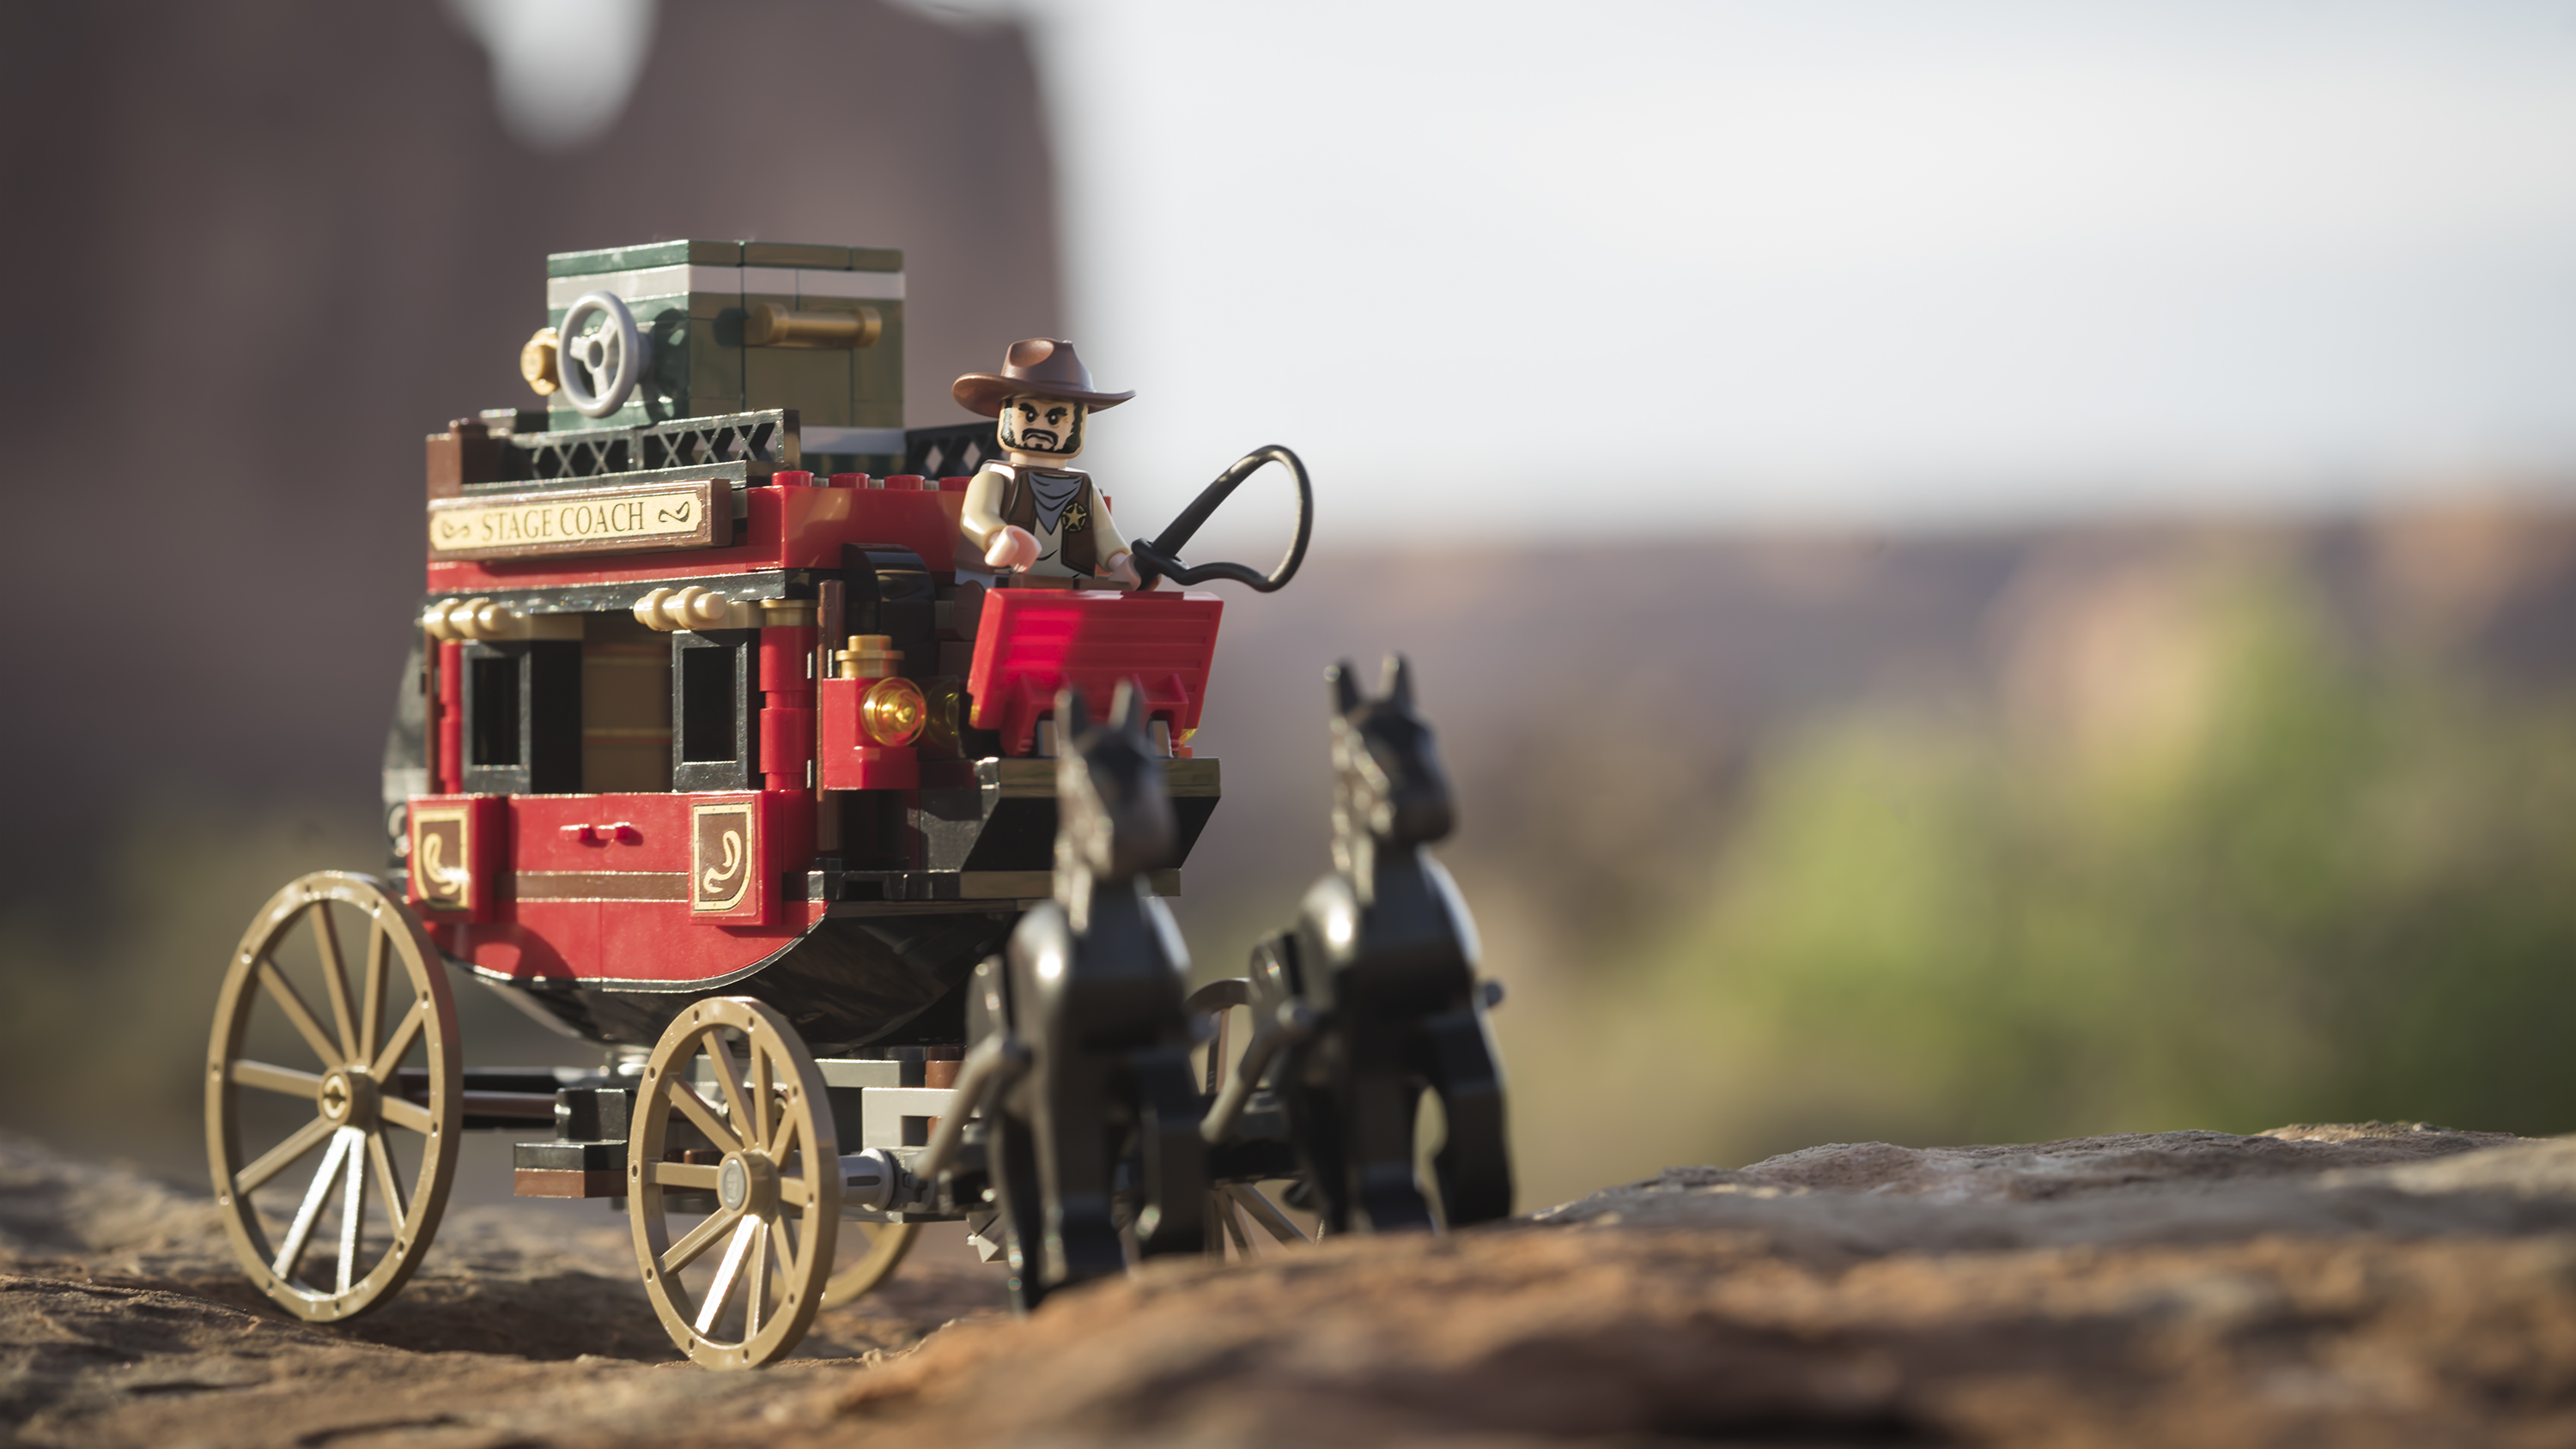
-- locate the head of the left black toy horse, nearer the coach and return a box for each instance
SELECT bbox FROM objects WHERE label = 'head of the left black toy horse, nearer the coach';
[1056,680,1180,885]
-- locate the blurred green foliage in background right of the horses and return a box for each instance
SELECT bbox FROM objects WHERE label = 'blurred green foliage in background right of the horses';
[1522,567,2576,1197]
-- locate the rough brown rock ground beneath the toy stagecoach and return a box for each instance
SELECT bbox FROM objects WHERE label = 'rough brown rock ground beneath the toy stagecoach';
[0,1125,2576,1449]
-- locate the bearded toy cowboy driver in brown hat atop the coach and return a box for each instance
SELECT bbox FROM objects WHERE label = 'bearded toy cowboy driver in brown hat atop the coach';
[948,337,1136,590]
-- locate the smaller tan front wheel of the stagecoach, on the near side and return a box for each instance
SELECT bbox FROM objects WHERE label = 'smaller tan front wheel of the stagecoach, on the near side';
[626,996,840,1369]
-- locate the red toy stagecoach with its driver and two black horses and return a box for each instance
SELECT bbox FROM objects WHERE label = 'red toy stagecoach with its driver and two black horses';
[206,242,1512,1367]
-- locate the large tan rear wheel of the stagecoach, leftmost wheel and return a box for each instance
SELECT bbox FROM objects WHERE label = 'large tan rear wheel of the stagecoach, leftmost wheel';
[206,870,464,1323]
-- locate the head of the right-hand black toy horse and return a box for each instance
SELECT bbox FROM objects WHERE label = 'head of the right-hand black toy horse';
[1324,654,1455,888]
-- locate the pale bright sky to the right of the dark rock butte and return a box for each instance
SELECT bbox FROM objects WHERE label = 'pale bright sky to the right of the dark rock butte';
[474,0,2576,533]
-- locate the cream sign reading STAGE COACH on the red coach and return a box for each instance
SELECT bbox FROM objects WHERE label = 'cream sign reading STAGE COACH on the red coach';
[430,479,734,564]
